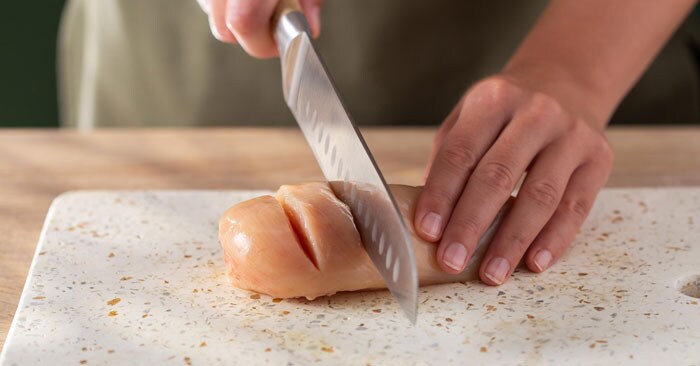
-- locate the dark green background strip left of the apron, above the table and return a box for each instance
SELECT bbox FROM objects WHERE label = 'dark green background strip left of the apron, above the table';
[0,0,700,127]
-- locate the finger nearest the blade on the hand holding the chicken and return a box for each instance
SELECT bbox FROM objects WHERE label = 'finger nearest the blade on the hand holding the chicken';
[414,79,519,241]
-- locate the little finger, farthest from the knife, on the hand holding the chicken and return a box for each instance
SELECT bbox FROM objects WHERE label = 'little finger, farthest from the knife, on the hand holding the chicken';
[525,144,612,273]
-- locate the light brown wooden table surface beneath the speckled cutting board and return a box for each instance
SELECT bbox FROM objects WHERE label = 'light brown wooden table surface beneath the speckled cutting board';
[0,127,700,346]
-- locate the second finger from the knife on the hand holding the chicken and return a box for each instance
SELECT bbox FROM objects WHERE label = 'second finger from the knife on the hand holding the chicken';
[437,96,566,273]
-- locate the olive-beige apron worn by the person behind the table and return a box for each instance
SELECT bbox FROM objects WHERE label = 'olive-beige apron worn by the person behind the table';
[59,0,700,128]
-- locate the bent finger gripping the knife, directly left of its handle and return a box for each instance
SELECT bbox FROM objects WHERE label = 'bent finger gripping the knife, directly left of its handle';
[225,0,278,58]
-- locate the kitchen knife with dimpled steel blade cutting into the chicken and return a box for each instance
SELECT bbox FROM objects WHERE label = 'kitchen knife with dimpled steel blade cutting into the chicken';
[272,0,418,324]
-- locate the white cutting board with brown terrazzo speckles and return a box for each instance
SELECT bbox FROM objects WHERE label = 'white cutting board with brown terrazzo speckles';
[0,188,700,365]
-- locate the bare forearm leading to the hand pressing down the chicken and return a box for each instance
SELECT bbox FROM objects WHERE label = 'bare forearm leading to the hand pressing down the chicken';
[504,0,697,128]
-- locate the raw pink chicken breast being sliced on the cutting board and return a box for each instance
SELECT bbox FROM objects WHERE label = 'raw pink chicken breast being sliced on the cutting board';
[219,183,498,299]
